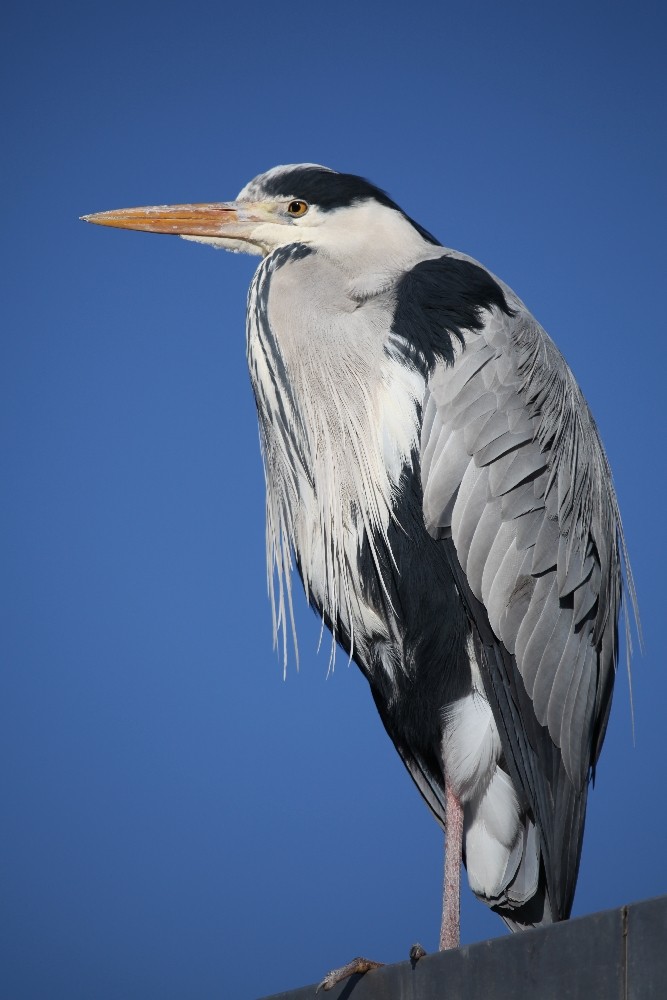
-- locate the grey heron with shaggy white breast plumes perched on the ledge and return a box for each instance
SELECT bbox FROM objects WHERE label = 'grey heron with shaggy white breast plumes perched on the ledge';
[84,164,635,984]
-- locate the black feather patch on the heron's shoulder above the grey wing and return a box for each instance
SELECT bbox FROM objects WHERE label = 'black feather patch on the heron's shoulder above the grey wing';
[387,254,513,374]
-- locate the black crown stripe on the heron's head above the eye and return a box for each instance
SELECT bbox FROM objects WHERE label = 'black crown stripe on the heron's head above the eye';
[262,166,439,246]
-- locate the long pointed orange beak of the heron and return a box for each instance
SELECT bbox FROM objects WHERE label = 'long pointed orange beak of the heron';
[81,202,261,239]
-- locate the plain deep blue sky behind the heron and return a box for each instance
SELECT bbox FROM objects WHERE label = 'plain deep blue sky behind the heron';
[0,0,667,1000]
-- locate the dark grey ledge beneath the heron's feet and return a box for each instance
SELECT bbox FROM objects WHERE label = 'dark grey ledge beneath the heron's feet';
[265,896,667,1000]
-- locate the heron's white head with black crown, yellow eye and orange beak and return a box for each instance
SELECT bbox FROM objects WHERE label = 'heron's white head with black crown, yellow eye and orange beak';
[83,163,437,256]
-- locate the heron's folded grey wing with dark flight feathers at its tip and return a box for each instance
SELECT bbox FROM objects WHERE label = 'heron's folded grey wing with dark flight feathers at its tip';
[421,296,636,917]
